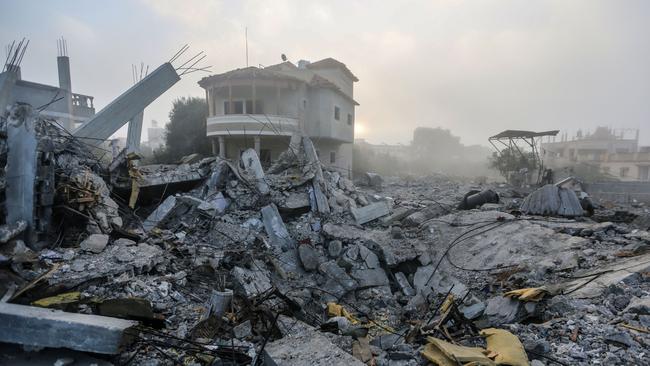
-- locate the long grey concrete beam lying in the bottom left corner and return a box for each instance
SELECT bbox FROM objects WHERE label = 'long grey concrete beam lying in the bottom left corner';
[0,303,138,354]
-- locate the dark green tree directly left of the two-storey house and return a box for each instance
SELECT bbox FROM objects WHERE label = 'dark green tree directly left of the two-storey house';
[154,97,211,163]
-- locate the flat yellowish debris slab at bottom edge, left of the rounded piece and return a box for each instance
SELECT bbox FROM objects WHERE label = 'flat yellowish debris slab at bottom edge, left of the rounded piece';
[422,337,496,366]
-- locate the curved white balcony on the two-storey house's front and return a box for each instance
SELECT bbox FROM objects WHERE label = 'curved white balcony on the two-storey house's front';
[206,114,300,136]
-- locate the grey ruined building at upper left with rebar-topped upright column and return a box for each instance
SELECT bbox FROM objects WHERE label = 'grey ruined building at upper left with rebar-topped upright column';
[7,44,95,131]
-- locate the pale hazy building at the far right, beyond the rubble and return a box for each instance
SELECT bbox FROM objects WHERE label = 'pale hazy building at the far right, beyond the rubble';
[541,127,650,181]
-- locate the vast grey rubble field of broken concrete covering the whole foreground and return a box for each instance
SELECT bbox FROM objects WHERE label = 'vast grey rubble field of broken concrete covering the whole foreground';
[0,104,650,366]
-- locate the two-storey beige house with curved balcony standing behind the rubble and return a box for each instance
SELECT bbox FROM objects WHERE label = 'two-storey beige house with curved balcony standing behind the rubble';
[199,58,358,175]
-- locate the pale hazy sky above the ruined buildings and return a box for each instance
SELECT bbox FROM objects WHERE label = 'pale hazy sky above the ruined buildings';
[0,0,650,145]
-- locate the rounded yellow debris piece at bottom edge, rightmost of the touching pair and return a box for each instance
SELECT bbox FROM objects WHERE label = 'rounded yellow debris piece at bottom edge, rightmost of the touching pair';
[481,328,529,366]
